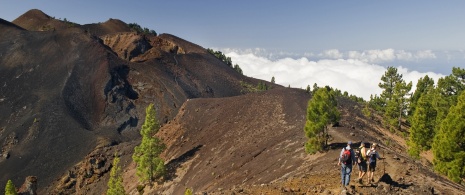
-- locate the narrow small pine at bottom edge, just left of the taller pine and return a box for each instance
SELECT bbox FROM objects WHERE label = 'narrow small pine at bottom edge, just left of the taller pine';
[107,154,126,195]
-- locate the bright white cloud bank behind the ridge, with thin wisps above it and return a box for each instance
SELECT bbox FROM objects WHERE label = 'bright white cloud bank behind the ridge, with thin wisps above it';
[225,50,444,100]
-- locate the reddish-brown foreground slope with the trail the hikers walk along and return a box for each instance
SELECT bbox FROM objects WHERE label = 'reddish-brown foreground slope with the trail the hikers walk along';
[118,88,465,194]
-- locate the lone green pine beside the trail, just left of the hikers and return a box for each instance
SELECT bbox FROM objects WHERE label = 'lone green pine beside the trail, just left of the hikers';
[304,88,341,154]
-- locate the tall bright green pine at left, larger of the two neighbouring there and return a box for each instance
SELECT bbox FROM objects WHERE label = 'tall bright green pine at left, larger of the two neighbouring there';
[132,104,165,184]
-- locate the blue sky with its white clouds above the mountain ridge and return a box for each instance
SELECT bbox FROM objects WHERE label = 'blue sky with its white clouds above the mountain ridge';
[0,0,465,98]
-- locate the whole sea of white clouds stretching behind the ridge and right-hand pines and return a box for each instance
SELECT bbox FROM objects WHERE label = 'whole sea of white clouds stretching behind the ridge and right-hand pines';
[217,48,445,100]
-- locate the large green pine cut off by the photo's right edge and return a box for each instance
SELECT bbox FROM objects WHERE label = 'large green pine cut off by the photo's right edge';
[433,92,465,182]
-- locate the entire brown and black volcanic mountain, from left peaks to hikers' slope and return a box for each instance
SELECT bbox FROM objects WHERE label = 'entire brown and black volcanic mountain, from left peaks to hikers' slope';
[0,10,465,194]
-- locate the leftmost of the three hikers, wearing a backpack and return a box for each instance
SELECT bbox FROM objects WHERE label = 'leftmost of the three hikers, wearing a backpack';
[337,141,357,190]
